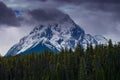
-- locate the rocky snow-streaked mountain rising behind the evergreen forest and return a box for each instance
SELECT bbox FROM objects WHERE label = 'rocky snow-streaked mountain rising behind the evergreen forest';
[6,15,107,56]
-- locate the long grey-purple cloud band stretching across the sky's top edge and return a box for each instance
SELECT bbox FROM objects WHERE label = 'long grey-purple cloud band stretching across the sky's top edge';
[3,0,120,9]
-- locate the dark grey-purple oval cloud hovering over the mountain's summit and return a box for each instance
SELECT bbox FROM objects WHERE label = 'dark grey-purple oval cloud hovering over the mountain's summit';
[29,8,67,22]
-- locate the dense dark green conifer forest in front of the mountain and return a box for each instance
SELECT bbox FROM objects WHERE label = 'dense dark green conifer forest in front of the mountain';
[0,40,120,80]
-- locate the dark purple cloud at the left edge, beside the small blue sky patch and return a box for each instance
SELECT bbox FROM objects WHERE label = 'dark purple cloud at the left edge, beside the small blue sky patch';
[0,2,19,26]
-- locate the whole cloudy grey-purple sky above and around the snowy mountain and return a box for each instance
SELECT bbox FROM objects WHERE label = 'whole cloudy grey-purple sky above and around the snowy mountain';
[0,0,120,55]
